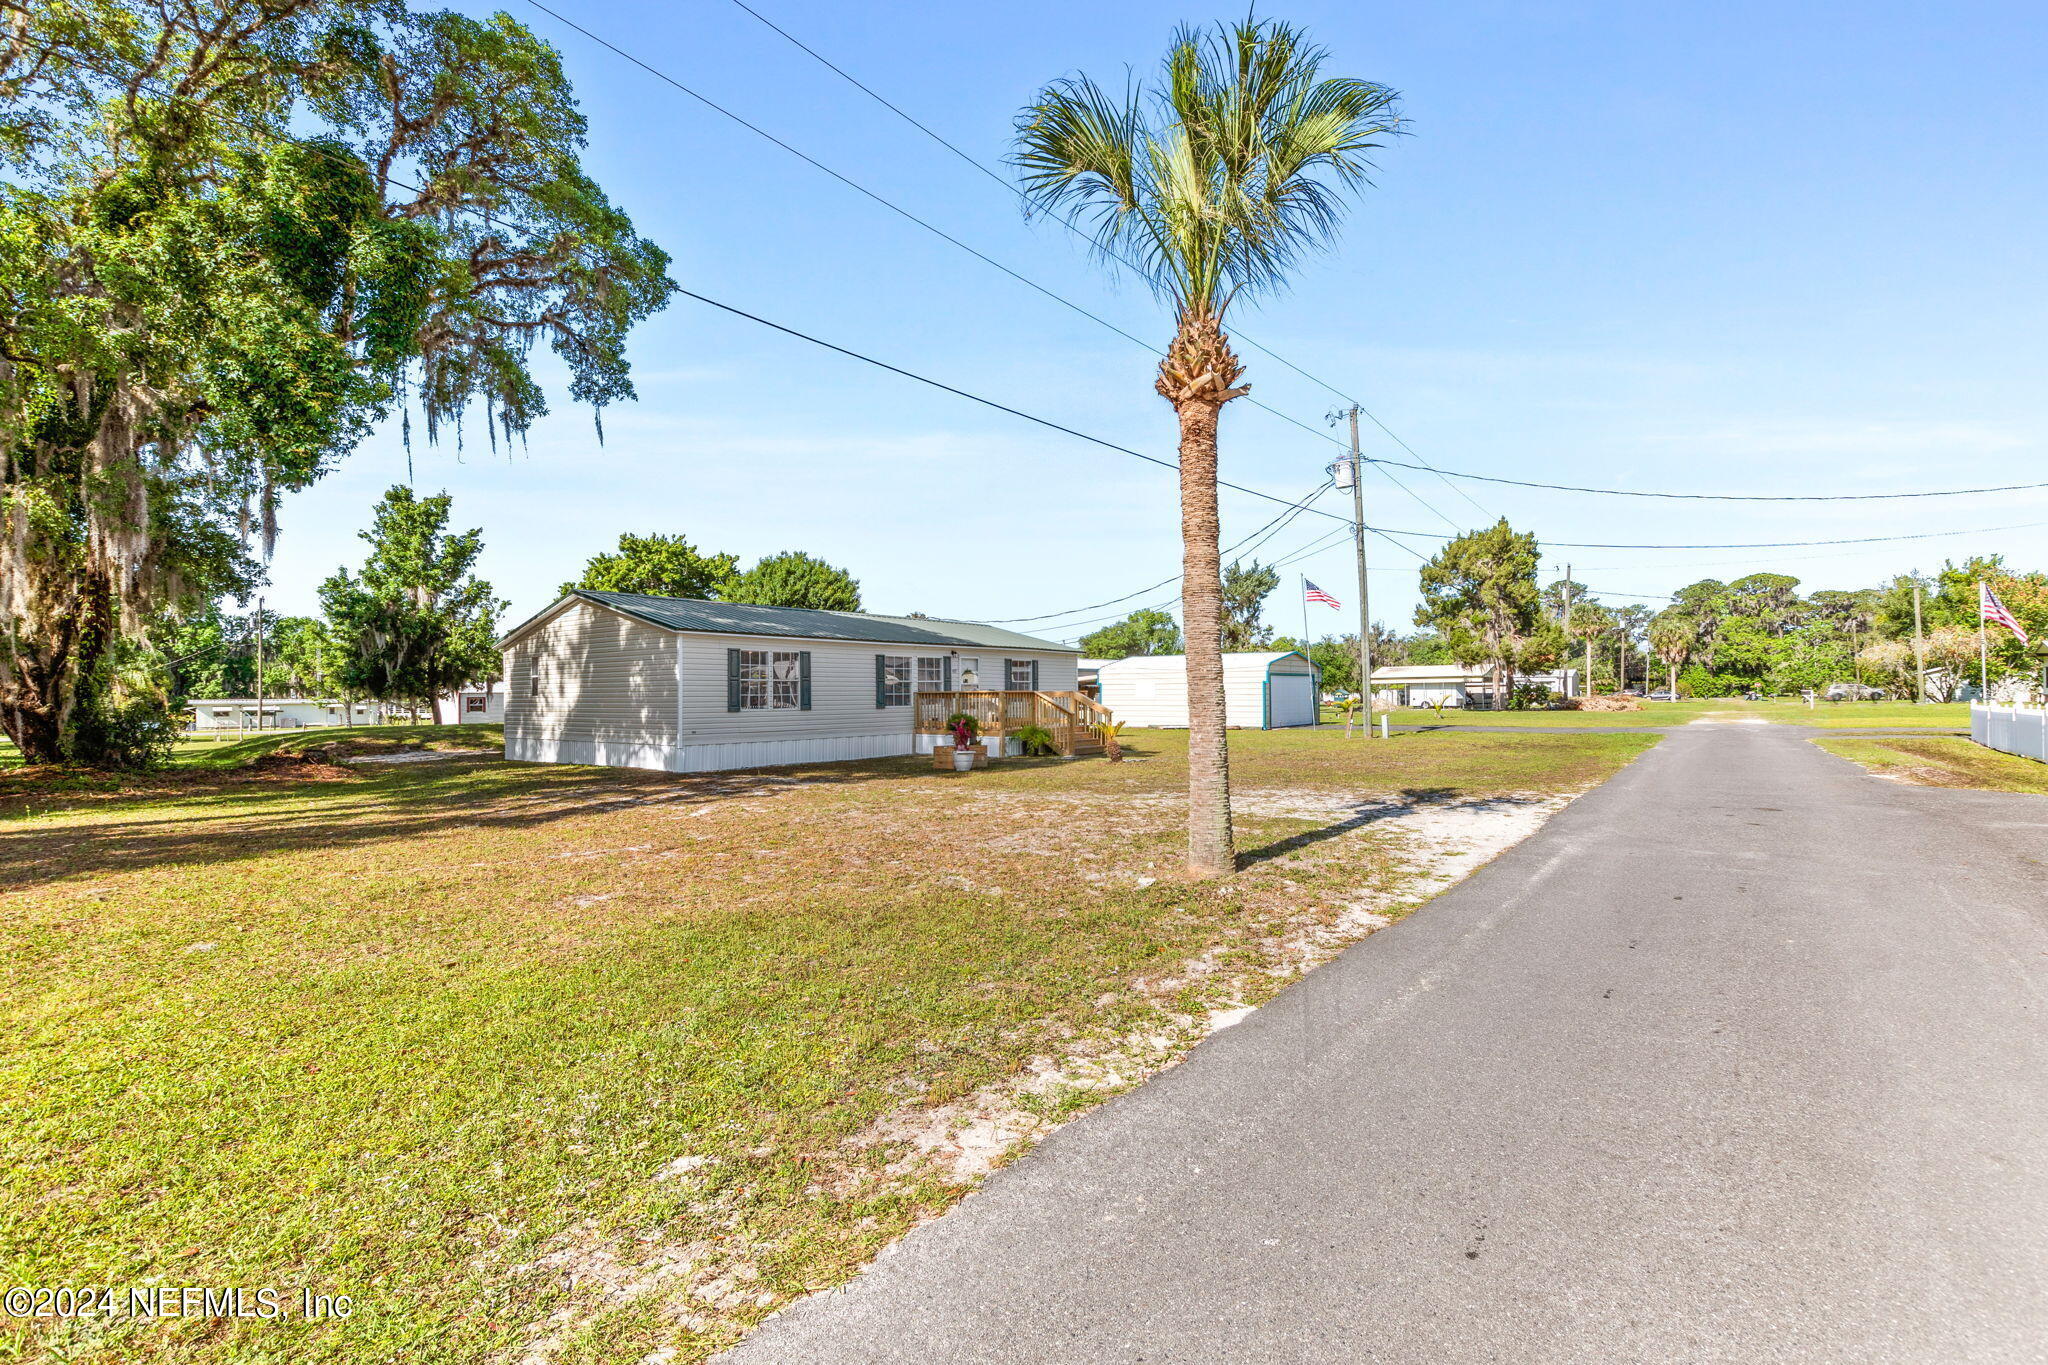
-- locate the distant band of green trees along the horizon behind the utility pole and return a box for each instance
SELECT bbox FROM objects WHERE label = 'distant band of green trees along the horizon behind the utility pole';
[1079,518,2048,700]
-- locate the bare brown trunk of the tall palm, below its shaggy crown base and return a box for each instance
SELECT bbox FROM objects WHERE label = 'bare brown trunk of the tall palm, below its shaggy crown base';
[1174,399,1237,876]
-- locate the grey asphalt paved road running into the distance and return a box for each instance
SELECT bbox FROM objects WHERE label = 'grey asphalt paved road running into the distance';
[729,724,2048,1365]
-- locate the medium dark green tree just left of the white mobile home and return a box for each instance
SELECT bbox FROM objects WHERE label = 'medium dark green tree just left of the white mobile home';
[319,487,504,722]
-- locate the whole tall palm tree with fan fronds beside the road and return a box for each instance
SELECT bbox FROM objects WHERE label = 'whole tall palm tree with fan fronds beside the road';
[1012,18,1401,876]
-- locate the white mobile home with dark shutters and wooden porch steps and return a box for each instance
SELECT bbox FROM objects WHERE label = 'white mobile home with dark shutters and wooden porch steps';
[500,589,1100,772]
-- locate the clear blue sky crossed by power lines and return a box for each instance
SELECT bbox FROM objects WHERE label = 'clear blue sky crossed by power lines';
[256,0,2048,639]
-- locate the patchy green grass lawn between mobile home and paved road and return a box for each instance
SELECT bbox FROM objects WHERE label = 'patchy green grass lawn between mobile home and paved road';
[0,726,1655,1365]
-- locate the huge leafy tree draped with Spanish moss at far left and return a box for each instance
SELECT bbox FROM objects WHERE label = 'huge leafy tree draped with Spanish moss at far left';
[0,0,674,761]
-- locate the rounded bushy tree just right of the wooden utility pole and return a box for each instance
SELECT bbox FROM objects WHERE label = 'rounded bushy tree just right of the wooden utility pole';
[1415,518,1544,698]
